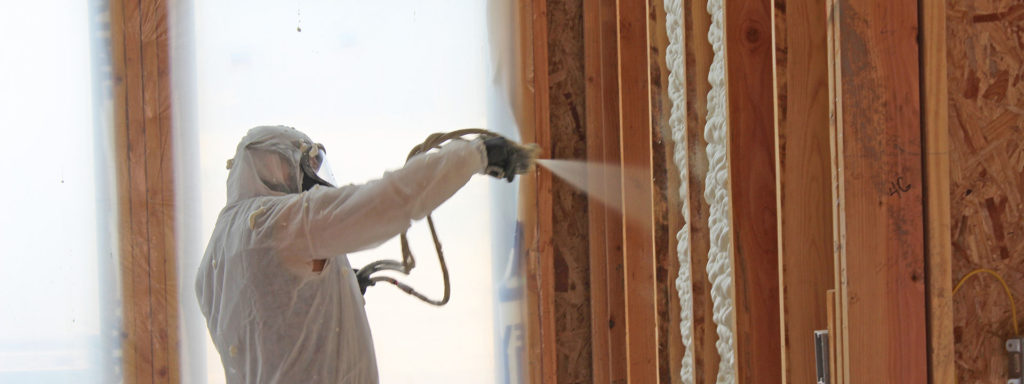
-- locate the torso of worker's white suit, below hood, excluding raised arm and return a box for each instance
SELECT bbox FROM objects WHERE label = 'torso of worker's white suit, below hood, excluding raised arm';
[196,195,377,383]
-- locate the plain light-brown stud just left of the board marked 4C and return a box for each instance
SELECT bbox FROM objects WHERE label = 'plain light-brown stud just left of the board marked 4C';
[772,0,834,383]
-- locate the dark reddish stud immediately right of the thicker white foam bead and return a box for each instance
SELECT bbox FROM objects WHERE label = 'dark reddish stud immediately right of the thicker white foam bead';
[724,1,781,383]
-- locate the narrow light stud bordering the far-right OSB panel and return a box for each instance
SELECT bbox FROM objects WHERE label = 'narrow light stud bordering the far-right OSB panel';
[921,0,956,383]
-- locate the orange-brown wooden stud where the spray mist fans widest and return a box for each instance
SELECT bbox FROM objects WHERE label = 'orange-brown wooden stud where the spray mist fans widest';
[617,0,658,383]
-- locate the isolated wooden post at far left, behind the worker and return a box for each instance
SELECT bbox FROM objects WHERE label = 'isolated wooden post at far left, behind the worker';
[111,0,180,383]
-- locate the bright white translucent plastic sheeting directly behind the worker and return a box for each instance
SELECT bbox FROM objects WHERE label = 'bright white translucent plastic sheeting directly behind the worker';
[170,0,505,383]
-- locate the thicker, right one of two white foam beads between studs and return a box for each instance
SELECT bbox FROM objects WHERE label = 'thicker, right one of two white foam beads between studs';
[705,0,736,384]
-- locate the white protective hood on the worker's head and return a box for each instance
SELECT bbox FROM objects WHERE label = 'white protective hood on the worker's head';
[227,126,315,204]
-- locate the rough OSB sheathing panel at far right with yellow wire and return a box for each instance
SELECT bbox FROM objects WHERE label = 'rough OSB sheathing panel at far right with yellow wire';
[947,0,1024,383]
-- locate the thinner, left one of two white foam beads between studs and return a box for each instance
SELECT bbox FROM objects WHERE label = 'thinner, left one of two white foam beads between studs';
[665,0,693,384]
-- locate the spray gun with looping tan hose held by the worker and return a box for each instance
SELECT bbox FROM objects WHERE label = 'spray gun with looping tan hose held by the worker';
[355,128,541,306]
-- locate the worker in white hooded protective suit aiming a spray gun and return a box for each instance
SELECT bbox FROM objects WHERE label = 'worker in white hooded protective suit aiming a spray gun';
[196,126,519,384]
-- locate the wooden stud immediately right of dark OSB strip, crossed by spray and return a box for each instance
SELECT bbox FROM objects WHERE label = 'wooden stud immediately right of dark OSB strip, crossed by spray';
[583,0,626,383]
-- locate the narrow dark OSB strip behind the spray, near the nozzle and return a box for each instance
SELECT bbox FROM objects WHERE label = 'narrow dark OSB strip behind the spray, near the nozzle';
[547,0,593,383]
